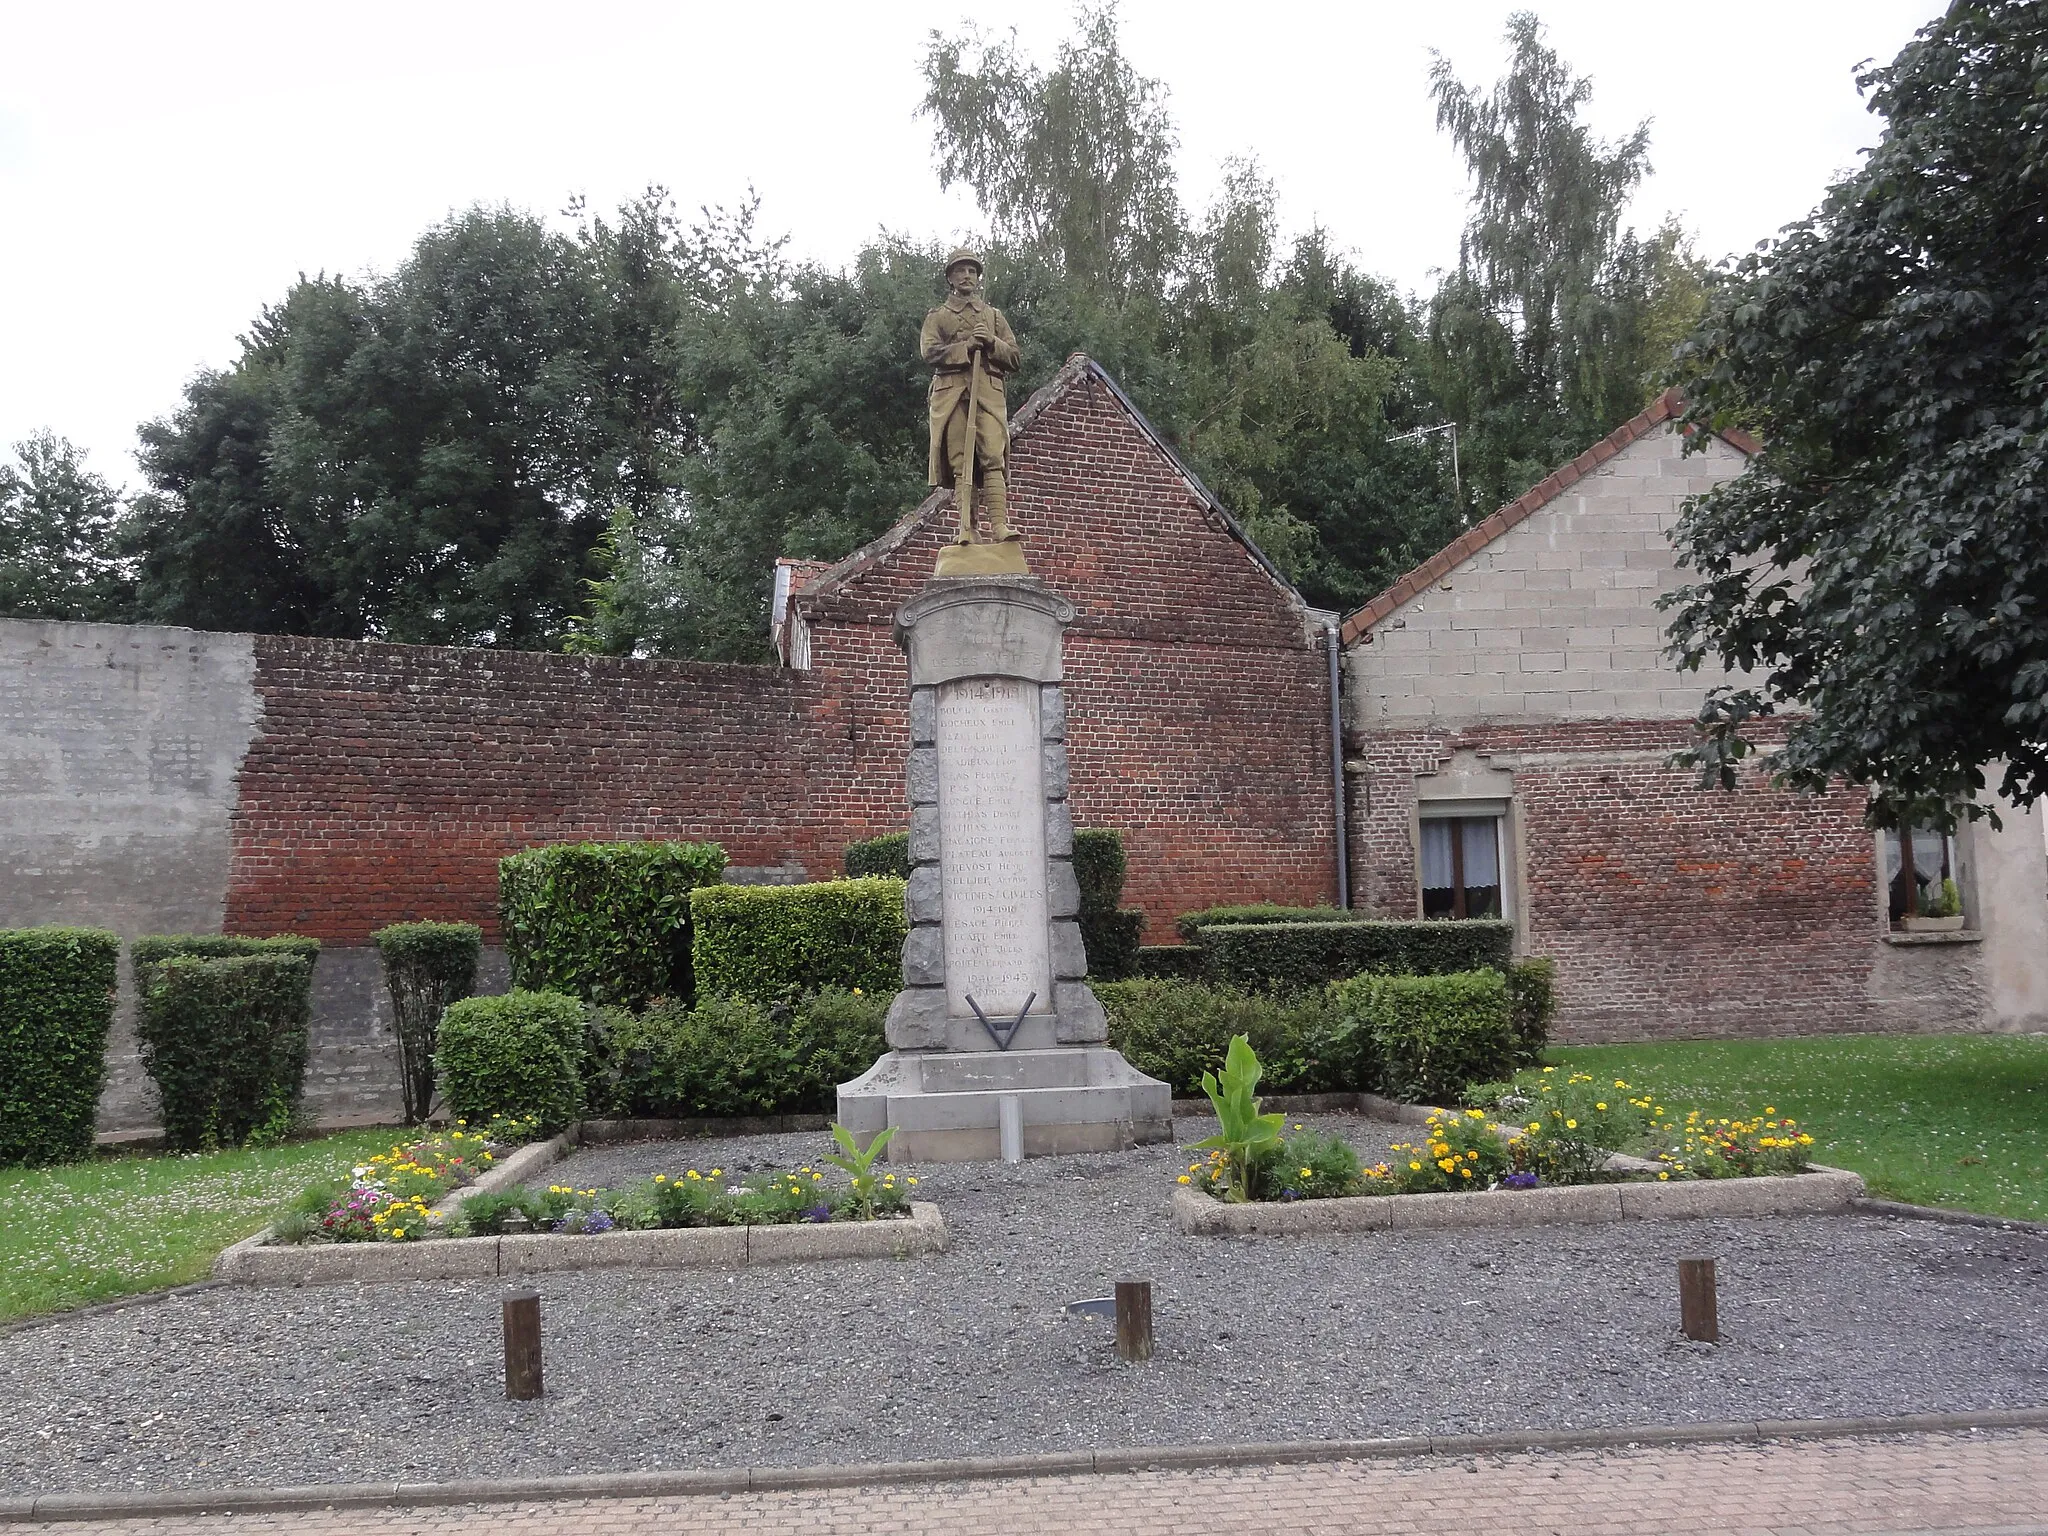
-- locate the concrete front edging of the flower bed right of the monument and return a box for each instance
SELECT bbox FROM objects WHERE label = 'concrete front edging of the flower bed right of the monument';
[1171,1165,1864,1237]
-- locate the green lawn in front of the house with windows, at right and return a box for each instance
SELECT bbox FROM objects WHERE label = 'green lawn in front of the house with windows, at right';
[1546,1034,2048,1221]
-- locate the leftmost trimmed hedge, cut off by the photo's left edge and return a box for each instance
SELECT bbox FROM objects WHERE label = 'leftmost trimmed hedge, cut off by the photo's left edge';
[0,928,121,1165]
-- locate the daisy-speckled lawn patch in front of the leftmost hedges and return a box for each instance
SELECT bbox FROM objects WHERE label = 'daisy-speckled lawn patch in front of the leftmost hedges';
[0,1130,393,1323]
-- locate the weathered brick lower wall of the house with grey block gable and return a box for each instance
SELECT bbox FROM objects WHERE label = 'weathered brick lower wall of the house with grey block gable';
[1350,721,1980,1040]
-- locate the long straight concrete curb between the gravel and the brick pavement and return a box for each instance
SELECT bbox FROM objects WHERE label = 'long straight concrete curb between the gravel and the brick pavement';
[0,1407,2048,1524]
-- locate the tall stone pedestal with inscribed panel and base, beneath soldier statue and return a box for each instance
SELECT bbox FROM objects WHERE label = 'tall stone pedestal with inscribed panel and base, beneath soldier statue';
[840,575,1174,1161]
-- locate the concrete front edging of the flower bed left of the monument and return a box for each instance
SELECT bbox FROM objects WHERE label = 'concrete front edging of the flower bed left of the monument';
[213,1200,946,1286]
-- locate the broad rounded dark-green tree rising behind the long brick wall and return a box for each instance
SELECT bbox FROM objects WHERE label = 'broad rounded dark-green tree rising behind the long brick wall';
[131,197,690,647]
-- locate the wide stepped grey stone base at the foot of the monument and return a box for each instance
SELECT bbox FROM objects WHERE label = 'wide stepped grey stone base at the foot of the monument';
[840,1044,1174,1163]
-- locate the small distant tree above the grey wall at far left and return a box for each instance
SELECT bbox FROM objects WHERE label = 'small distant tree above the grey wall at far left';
[0,430,135,623]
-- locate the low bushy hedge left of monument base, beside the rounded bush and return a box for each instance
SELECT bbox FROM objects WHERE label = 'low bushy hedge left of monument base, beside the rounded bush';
[588,987,889,1118]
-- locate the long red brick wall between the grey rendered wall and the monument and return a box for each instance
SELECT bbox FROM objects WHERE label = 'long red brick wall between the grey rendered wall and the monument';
[227,637,901,944]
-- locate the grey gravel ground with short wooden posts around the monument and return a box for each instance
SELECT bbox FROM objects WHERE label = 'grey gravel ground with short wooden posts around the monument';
[0,1116,2048,1493]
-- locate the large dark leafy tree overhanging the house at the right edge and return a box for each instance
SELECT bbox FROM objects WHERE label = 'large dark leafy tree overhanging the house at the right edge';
[1665,0,2048,825]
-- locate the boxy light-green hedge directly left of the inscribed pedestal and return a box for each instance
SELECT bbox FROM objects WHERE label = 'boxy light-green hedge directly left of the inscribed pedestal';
[690,874,909,1004]
